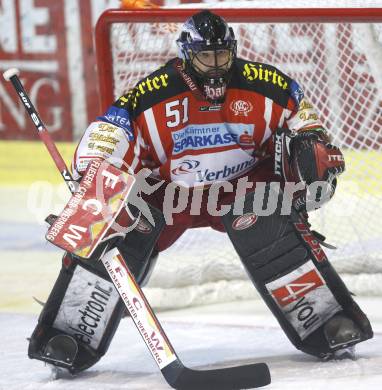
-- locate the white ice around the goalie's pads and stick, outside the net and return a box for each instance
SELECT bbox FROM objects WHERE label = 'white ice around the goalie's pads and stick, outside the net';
[0,187,382,390]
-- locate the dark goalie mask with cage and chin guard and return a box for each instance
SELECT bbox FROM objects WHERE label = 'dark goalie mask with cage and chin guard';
[177,11,237,103]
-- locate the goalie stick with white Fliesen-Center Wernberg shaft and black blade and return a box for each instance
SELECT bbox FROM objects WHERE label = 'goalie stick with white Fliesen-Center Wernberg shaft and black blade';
[3,68,271,390]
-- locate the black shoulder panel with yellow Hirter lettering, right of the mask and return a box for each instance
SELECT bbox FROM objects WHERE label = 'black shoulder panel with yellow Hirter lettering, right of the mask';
[231,58,302,107]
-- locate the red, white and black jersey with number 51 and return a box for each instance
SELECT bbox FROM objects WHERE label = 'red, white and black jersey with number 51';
[73,59,322,187]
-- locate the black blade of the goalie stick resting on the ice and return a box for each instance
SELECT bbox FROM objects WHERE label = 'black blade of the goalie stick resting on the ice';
[162,361,271,390]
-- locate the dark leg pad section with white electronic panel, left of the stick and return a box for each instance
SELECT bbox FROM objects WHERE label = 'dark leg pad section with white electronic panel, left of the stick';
[28,254,124,374]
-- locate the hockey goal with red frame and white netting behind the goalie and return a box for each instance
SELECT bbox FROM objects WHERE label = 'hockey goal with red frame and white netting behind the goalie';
[96,8,382,308]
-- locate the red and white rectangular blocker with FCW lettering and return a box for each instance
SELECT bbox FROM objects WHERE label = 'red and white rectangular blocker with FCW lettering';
[46,159,136,259]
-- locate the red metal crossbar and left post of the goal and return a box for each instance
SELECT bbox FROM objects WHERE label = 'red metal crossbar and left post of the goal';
[95,8,382,111]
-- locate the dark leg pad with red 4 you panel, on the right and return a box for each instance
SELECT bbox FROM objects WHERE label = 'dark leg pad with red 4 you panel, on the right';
[222,186,373,357]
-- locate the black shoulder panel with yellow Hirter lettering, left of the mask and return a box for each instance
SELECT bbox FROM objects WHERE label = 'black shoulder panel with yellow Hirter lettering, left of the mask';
[114,59,188,119]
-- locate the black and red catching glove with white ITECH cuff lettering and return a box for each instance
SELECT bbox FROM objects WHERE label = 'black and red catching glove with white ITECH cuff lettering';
[275,129,345,211]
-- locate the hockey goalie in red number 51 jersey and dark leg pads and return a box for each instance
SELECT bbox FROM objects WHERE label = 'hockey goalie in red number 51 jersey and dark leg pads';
[28,11,373,373]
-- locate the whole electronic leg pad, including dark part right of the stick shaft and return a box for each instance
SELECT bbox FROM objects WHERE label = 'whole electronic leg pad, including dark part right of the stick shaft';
[28,207,164,374]
